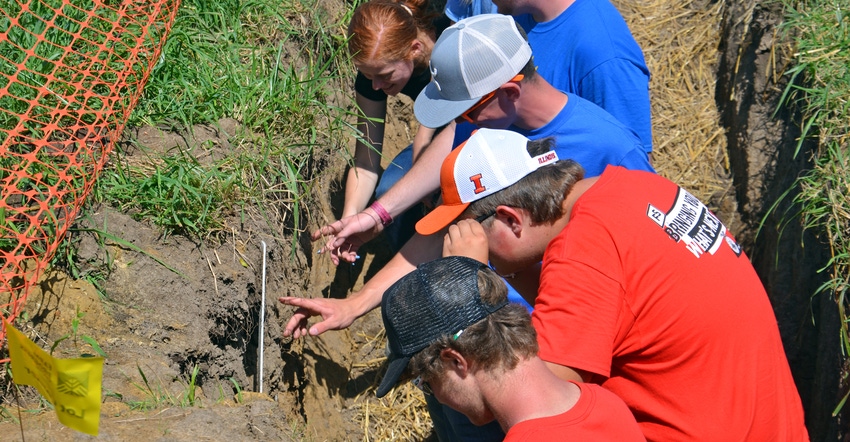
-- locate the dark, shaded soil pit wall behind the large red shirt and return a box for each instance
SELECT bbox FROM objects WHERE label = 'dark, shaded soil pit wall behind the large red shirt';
[716,0,848,441]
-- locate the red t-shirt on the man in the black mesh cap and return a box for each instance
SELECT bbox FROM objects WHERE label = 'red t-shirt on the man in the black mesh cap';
[505,383,646,442]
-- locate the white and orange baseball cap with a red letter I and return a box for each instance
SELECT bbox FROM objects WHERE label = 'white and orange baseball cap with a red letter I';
[416,129,558,235]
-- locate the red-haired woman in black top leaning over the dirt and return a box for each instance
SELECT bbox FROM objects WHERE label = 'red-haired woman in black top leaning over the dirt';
[334,0,449,250]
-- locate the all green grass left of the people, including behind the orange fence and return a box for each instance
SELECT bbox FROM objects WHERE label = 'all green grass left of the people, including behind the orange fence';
[0,0,352,414]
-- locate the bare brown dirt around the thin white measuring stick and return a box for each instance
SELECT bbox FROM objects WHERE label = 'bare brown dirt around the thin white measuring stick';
[0,94,415,441]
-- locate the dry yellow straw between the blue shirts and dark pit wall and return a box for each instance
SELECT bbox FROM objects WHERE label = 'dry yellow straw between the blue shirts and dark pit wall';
[613,0,732,216]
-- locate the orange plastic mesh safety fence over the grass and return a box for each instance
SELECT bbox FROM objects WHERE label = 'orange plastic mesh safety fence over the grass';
[0,0,179,352]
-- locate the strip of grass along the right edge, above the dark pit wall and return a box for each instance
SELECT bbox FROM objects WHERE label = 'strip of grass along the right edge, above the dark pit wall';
[784,0,850,415]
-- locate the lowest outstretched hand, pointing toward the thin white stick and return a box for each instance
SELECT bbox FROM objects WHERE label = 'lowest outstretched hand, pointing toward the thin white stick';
[278,296,360,339]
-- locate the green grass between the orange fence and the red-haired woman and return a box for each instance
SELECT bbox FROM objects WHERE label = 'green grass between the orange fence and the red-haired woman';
[94,0,351,252]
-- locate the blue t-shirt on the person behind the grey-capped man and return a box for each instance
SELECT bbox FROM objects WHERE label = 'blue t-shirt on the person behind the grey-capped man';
[516,0,652,152]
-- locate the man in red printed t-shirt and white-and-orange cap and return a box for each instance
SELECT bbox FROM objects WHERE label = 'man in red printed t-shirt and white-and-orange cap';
[417,129,808,441]
